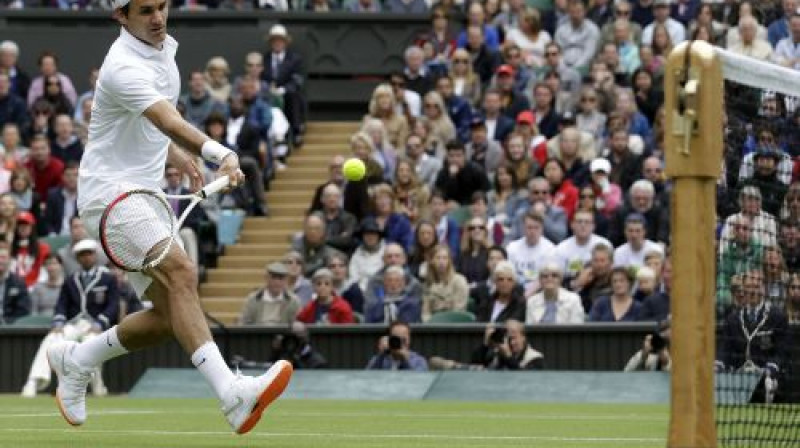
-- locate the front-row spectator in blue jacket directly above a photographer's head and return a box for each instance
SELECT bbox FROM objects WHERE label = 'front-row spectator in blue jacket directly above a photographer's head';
[364,266,422,324]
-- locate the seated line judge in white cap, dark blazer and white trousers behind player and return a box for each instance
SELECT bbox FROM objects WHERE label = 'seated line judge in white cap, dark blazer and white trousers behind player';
[22,239,119,397]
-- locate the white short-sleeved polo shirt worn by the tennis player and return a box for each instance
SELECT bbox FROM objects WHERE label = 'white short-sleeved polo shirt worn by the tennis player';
[78,28,181,210]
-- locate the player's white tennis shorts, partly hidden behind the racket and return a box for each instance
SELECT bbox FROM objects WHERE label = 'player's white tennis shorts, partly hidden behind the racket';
[80,190,183,299]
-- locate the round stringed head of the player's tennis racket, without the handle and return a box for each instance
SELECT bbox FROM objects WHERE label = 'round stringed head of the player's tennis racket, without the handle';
[100,191,175,271]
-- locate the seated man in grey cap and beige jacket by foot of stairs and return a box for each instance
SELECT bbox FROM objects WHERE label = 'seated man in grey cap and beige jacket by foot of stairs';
[239,262,300,325]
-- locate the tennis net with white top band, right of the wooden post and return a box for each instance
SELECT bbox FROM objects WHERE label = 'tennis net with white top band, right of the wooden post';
[715,47,800,447]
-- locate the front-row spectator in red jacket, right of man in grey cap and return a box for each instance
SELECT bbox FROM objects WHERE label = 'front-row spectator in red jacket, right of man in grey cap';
[297,268,353,324]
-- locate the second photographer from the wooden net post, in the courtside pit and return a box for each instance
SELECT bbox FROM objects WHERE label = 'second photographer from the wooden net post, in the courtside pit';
[472,319,544,370]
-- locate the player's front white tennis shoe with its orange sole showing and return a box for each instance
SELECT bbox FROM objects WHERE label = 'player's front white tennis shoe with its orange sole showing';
[221,361,293,434]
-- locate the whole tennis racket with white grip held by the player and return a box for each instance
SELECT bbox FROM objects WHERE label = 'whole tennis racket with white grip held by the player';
[100,176,230,272]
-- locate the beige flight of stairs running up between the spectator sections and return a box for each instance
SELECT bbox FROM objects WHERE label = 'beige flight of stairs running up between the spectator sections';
[200,122,360,324]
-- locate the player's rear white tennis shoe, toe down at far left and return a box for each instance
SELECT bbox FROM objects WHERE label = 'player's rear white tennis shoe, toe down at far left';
[47,341,94,426]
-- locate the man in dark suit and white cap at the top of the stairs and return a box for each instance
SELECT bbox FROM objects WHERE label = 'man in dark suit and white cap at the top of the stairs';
[261,25,306,146]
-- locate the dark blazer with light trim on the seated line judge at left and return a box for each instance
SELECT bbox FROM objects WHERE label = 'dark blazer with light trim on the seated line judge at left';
[53,266,119,330]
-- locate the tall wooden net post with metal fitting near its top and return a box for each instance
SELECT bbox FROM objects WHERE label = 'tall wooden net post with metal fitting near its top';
[664,41,723,448]
